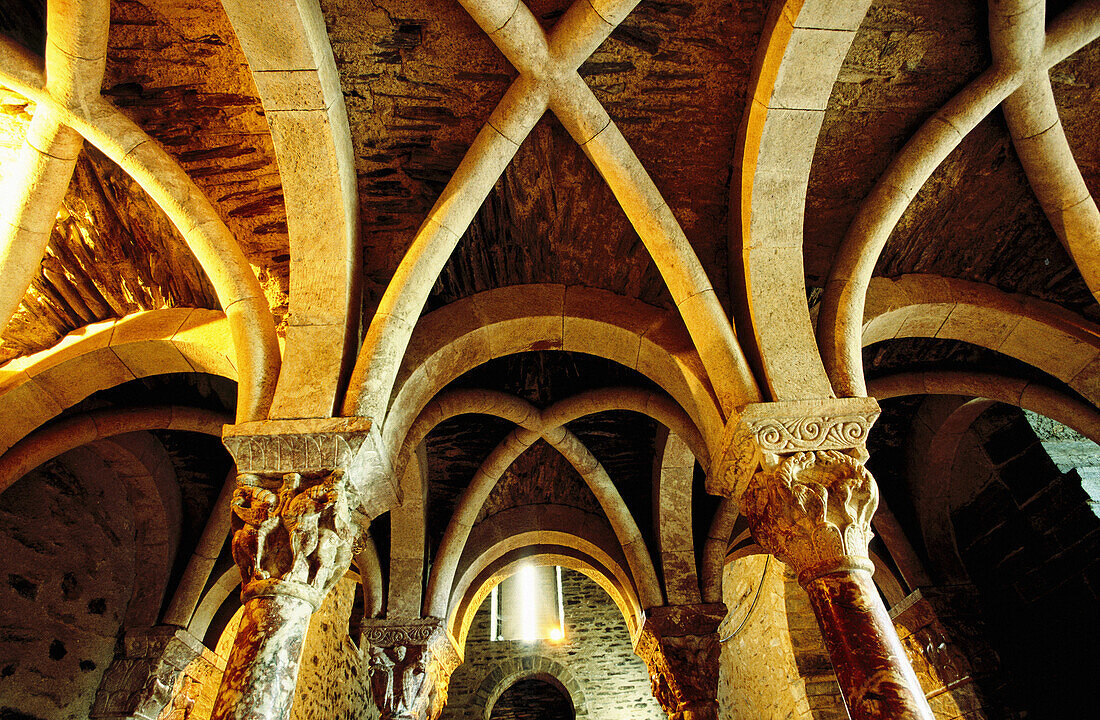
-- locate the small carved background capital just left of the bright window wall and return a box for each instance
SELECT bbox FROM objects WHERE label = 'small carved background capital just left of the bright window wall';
[363,618,462,720]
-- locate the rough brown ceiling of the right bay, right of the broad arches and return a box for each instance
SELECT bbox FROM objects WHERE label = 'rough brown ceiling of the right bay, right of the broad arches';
[805,0,1100,318]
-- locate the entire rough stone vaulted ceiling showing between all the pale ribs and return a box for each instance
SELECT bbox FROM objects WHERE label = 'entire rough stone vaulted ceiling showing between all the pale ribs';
[0,0,1100,593]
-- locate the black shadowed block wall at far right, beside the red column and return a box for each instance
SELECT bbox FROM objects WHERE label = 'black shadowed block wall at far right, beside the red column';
[952,406,1100,719]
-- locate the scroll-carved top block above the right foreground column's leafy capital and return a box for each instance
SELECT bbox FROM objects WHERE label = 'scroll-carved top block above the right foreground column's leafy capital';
[706,398,879,500]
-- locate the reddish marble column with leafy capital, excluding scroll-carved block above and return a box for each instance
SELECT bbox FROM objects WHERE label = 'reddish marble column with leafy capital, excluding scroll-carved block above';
[741,450,933,720]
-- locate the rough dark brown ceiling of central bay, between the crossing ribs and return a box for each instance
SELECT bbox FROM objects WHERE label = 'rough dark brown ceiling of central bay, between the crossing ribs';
[321,0,765,316]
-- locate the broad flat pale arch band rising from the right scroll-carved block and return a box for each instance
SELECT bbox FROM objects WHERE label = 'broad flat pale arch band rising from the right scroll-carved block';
[729,0,870,400]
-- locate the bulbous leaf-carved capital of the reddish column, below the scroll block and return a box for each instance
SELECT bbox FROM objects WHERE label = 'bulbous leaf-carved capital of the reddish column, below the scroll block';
[740,450,879,573]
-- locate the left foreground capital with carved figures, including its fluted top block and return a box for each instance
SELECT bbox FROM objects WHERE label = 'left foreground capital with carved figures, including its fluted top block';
[222,418,397,610]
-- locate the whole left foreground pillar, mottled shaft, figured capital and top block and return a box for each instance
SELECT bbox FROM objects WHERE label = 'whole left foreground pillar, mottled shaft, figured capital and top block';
[211,418,396,720]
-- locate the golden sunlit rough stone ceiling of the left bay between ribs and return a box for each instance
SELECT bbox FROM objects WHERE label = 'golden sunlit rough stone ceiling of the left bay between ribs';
[0,0,289,362]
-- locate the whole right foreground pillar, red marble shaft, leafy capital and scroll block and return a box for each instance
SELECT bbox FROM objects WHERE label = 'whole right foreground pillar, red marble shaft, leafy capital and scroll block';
[708,398,933,720]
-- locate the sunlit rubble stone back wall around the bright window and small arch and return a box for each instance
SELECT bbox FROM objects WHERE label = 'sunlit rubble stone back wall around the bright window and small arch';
[442,568,666,720]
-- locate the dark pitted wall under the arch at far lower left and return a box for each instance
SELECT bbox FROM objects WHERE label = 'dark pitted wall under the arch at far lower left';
[0,459,135,720]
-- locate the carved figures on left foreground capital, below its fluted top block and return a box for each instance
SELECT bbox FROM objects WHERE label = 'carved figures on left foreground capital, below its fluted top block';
[231,470,356,608]
